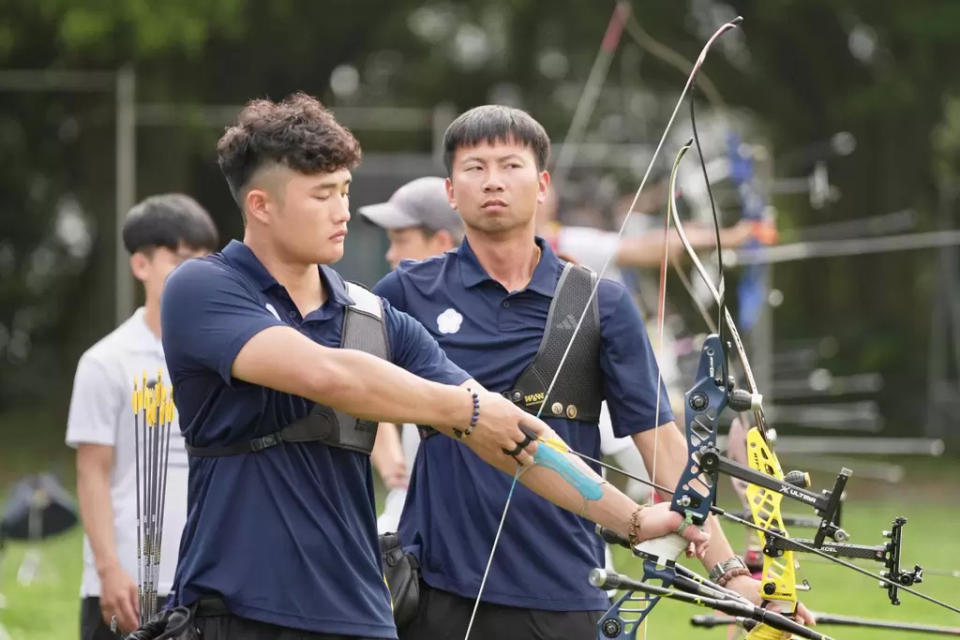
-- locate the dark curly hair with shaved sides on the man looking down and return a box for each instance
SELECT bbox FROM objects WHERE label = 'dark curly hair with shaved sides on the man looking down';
[217,93,360,211]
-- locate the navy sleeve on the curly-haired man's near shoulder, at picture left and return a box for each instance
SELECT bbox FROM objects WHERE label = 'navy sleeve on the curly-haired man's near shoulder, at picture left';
[161,259,284,384]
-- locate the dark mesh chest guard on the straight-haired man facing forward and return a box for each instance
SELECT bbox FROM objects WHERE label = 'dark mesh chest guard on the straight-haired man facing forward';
[504,263,603,422]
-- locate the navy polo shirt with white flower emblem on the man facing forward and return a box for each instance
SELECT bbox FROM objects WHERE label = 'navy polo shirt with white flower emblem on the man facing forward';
[374,238,673,611]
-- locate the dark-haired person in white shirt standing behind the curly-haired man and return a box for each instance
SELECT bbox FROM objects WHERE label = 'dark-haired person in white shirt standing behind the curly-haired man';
[66,194,218,640]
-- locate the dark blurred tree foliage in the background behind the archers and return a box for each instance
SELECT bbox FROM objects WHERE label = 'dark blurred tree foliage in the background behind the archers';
[0,0,960,440]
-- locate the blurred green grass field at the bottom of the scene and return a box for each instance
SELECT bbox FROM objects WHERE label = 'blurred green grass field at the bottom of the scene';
[0,450,960,640]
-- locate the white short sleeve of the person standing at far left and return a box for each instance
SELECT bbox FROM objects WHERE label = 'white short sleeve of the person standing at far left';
[66,353,121,447]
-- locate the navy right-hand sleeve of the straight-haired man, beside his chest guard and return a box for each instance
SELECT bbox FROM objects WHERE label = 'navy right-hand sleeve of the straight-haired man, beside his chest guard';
[597,280,673,437]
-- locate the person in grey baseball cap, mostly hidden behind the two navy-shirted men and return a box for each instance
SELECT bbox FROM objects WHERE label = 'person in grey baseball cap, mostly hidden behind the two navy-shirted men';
[358,177,463,533]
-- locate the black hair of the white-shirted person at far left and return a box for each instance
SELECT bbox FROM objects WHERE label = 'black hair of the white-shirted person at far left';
[123,193,220,253]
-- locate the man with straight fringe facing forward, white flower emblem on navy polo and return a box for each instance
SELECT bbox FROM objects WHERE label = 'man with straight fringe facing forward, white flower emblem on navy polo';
[374,105,804,640]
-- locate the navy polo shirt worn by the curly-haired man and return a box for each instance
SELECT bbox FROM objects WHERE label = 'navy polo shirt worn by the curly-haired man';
[162,241,468,638]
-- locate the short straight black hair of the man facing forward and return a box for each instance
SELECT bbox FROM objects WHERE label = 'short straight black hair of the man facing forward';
[443,104,550,174]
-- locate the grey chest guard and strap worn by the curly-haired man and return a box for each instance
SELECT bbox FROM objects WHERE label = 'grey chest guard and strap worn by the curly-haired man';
[187,282,389,458]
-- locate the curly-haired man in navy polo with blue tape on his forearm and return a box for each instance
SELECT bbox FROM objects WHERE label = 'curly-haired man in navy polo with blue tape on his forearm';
[162,94,707,640]
